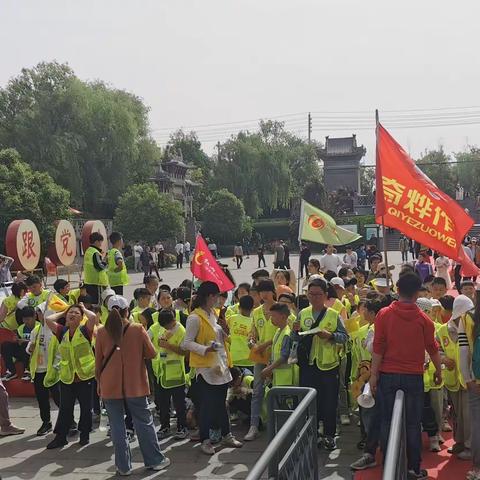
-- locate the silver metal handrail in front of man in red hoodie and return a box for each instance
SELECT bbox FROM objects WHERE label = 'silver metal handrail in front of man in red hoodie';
[383,390,408,480]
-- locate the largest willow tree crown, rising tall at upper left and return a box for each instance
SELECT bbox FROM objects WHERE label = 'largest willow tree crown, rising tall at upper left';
[0,62,160,216]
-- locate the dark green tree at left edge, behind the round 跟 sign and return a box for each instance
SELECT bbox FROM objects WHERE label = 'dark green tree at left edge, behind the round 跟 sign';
[0,149,70,254]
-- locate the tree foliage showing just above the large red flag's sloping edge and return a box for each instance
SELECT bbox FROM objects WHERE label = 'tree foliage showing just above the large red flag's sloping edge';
[417,148,457,198]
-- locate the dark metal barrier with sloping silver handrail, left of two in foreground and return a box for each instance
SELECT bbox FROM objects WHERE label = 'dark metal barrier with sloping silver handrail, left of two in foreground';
[247,387,318,480]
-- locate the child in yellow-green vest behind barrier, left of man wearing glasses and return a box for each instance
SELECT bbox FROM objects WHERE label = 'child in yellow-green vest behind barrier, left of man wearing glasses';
[262,303,298,387]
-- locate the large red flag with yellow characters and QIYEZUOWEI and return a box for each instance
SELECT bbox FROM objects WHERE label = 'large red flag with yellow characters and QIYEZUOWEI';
[375,123,473,261]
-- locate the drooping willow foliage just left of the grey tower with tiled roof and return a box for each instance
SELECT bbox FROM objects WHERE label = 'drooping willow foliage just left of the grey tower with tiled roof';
[212,121,320,218]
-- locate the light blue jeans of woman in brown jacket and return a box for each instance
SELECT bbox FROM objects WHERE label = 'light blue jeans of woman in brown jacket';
[104,397,165,472]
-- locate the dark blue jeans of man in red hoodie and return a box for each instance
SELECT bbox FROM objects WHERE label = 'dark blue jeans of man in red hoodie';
[376,373,424,473]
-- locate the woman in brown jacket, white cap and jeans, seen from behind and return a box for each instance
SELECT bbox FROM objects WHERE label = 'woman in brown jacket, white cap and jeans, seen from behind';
[95,295,170,475]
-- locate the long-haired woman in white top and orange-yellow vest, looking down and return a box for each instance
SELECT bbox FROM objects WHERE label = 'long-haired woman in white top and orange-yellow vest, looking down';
[182,282,242,455]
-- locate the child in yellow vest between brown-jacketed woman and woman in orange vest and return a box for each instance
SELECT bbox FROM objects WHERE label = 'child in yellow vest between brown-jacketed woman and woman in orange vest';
[148,308,188,440]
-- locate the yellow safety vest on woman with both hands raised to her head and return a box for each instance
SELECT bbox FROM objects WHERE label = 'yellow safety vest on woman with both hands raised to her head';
[58,327,95,384]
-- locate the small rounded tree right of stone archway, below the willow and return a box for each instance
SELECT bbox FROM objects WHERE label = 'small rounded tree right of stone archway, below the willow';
[202,188,252,244]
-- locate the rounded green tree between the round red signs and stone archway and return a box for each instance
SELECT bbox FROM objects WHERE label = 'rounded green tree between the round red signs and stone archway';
[114,183,185,244]
